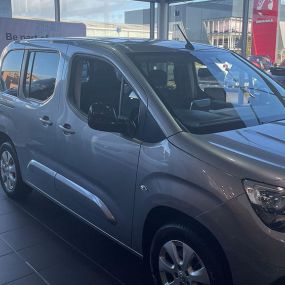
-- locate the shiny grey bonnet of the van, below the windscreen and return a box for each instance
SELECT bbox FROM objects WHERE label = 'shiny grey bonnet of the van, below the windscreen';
[170,121,285,186]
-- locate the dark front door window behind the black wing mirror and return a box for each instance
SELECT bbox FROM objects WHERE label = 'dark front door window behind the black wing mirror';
[70,56,140,125]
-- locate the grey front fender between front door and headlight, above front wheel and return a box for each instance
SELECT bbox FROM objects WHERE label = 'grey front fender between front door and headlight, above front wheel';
[133,139,243,253]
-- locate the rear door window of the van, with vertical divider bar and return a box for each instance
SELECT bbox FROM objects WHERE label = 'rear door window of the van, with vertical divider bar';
[24,51,59,101]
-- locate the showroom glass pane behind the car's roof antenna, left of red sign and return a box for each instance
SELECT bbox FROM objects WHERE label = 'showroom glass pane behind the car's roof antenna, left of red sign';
[169,0,242,53]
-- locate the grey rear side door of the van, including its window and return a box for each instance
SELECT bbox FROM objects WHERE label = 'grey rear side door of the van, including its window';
[13,49,64,197]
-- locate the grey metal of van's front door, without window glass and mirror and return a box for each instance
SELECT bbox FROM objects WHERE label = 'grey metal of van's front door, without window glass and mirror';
[55,43,141,246]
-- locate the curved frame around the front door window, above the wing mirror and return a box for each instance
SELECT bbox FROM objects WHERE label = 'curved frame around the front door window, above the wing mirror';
[66,52,144,129]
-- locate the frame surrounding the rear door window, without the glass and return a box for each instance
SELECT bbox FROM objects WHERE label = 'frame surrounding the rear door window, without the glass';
[20,48,61,105]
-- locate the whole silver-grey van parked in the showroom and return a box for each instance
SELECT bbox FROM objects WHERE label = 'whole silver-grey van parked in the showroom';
[0,38,285,285]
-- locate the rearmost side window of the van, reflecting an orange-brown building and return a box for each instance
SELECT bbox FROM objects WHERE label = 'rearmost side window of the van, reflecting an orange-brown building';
[0,50,24,96]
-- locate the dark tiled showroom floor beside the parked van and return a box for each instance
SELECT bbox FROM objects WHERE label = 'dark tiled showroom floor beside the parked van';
[0,189,151,285]
